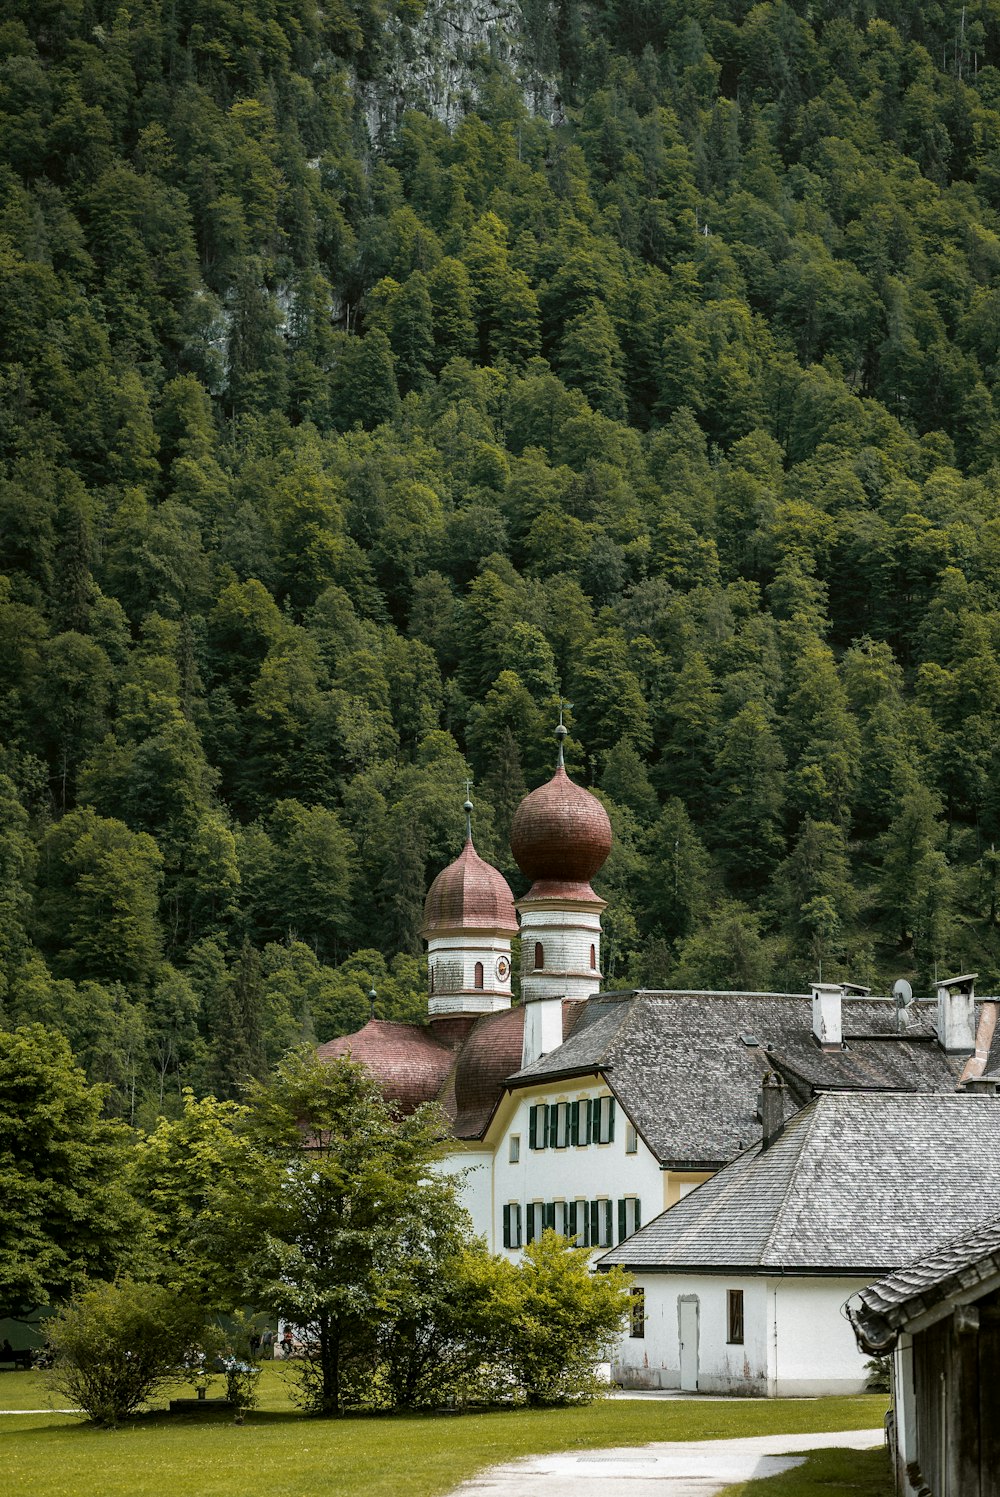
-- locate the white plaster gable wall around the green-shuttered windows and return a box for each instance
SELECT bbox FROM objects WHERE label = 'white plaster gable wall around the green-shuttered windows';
[493,1082,663,1259]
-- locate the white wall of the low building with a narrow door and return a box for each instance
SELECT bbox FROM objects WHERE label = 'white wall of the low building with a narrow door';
[611,1274,867,1398]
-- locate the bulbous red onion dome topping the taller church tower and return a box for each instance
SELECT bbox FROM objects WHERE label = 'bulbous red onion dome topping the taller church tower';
[510,751,611,885]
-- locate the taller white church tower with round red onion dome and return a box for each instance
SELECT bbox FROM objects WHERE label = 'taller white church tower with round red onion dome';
[510,722,611,1066]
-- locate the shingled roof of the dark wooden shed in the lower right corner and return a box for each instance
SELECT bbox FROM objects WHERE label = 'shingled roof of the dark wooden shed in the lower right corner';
[850,1209,1000,1353]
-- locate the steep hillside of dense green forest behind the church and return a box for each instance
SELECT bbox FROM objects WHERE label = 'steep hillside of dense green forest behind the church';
[0,0,1000,1120]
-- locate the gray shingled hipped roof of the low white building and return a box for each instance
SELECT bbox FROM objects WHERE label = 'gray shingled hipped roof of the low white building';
[600,1093,1000,1274]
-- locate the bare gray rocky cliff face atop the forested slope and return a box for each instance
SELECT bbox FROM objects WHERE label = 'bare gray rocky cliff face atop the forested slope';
[356,0,557,144]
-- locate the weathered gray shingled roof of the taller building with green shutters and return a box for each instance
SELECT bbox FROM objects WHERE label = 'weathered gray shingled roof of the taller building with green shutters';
[507,991,964,1169]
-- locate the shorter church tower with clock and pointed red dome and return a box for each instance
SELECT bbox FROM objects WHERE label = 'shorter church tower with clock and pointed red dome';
[421,801,518,1019]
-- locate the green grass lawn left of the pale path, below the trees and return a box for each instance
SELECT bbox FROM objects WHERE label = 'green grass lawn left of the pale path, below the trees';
[0,1364,886,1497]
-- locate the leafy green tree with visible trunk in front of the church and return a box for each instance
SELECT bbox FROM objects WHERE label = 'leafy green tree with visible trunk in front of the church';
[215,1054,458,1413]
